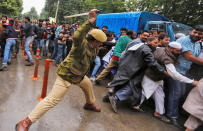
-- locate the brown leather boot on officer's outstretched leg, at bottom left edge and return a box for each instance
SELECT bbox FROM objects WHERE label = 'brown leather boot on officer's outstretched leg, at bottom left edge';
[16,117,32,131]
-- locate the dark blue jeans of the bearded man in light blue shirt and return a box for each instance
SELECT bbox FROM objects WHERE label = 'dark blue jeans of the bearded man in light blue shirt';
[167,78,186,118]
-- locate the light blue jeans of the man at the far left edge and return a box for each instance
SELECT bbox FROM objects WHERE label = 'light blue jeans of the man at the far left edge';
[3,40,16,65]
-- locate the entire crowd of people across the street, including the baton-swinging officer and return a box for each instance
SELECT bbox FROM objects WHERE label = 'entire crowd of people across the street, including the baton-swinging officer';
[0,8,203,131]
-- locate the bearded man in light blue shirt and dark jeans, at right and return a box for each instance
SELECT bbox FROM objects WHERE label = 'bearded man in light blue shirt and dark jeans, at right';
[167,26,203,128]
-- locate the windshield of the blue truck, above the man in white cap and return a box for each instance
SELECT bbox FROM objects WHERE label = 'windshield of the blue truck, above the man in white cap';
[172,23,192,36]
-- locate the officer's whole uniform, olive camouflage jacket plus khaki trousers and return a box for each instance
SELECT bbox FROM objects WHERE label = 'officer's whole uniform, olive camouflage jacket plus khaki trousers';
[28,22,98,122]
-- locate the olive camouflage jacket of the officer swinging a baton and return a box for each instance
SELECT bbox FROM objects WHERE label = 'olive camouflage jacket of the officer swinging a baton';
[57,22,99,84]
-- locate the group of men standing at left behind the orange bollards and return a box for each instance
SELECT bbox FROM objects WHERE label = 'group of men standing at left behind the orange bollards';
[0,15,80,71]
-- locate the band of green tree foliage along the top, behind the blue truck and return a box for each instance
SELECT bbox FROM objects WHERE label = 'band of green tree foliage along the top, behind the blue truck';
[42,0,203,26]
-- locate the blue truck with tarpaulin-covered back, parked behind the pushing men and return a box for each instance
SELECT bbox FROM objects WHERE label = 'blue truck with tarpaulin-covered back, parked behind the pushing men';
[96,11,192,41]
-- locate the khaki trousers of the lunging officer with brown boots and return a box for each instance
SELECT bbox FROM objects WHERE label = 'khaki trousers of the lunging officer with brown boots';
[28,76,95,123]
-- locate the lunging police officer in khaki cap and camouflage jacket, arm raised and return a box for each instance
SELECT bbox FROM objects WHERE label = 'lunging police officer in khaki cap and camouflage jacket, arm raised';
[16,9,107,131]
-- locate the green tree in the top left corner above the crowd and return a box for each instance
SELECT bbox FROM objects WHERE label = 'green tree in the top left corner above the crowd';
[0,0,23,16]
